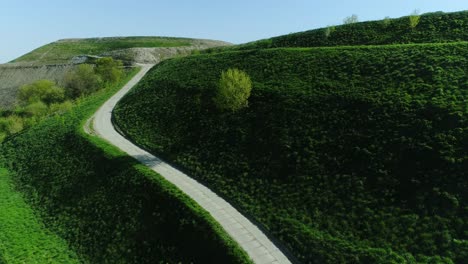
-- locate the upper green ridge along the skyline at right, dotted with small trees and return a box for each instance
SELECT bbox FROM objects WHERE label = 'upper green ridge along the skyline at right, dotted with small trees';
[218,11,468,49]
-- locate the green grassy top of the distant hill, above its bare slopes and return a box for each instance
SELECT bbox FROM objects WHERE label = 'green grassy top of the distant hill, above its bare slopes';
[13,37,193,63]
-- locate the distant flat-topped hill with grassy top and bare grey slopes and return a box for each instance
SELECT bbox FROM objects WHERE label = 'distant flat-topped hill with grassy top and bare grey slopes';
[0,37,230,108]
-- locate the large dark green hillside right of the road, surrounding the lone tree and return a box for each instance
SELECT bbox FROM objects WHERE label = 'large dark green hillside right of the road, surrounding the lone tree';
[114,42,468,263]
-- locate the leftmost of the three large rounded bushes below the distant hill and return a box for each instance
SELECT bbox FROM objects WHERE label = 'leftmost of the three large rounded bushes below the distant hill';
[18,80,65,105]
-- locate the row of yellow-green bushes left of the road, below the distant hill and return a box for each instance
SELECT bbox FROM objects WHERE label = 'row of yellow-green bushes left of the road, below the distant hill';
[0,57,124,142]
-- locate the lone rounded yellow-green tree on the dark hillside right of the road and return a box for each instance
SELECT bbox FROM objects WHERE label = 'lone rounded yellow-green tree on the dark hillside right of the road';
[213,69,252,112]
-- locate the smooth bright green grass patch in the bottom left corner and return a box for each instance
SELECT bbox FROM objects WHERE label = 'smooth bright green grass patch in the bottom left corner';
[0,168,79,263]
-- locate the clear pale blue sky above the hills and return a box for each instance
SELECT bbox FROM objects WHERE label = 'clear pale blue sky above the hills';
[0,0,468,63]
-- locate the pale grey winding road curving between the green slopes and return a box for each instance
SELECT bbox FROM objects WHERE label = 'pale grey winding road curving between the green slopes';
[85,65,291,264]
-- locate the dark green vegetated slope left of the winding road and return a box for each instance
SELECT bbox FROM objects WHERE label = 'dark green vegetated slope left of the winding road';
[0,68,250,263]
